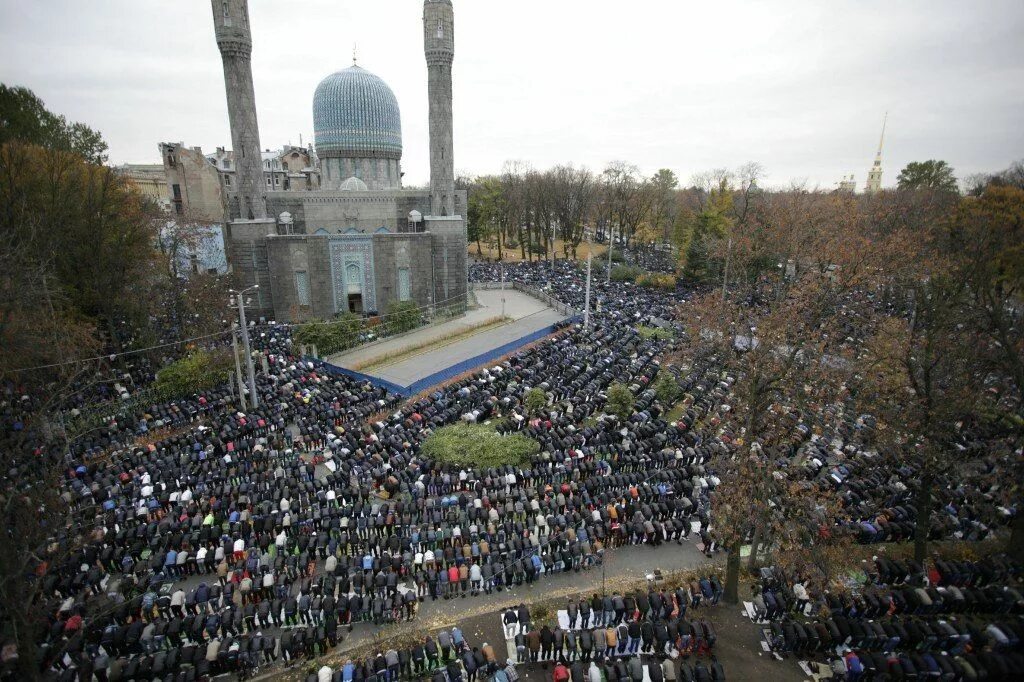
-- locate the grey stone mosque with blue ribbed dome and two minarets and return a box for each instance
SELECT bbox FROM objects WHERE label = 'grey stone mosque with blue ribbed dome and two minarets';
[212,0,467,322]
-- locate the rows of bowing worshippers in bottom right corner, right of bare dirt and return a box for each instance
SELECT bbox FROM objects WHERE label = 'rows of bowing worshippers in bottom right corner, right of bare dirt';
[752,556,1024,682]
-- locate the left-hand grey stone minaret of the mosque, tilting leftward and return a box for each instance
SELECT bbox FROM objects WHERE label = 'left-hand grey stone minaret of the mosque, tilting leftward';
[211,0,266,220]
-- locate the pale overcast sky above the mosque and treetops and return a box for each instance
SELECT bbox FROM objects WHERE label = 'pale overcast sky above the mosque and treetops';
[0,0,1024,188]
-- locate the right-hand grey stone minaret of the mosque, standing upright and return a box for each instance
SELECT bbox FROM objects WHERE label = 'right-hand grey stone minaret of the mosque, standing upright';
[423,0,455,216]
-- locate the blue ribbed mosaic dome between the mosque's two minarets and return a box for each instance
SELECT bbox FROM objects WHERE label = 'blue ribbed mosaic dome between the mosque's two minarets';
[313,66,401,159]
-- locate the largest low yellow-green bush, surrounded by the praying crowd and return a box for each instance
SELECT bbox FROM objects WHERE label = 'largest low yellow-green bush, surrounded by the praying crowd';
[420,423,540,468]
